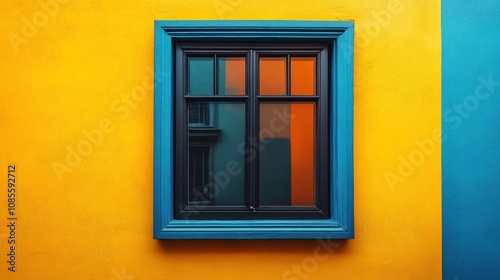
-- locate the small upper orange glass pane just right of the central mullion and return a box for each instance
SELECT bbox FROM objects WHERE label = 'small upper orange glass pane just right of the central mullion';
[259,57,286,95]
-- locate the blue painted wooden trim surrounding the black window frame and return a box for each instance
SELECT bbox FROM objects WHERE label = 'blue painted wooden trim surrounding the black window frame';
[153,21,354,239]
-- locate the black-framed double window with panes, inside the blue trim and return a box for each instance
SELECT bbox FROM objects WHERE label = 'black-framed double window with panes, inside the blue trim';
[174,41,331,219]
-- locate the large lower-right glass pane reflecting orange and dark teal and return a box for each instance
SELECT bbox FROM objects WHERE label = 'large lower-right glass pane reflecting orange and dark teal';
[259,103,316,206]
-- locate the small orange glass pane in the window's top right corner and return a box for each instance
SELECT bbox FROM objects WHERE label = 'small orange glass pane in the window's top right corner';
[290,57,316,95]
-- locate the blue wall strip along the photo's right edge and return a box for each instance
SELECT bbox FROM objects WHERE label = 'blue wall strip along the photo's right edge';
[442,0,500,280]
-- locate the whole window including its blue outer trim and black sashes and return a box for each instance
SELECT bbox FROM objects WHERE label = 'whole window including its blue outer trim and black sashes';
[154,21,353,239]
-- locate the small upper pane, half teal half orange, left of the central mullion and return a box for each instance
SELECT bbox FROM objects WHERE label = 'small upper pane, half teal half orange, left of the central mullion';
[218,57,246,95]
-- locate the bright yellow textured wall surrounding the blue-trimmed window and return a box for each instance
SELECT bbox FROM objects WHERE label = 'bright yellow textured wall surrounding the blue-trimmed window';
[0,0,441,280]
